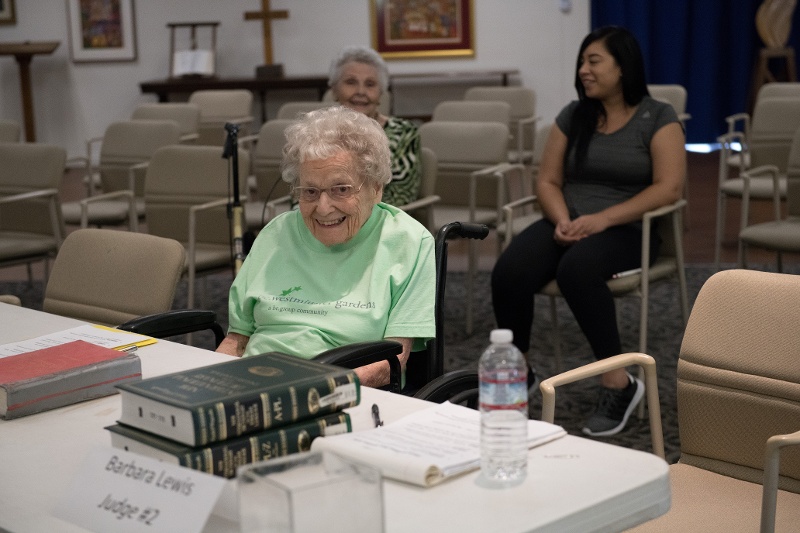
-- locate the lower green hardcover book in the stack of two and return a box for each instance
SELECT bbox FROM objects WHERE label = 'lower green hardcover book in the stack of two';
[106,413,352,478]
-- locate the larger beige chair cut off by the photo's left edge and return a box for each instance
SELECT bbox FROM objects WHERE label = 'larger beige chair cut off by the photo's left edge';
[0,143,67,280]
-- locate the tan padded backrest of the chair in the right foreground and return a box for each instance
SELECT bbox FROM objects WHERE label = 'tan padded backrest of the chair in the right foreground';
[678,270,800,492]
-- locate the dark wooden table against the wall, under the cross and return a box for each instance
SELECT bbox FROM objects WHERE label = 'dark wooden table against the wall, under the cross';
[139,76,328,122]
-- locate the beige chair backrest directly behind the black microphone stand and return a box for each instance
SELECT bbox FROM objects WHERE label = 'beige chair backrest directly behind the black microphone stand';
[144,145,250,244]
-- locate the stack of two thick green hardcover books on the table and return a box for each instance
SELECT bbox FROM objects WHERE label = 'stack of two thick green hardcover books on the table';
[106,353,361,478]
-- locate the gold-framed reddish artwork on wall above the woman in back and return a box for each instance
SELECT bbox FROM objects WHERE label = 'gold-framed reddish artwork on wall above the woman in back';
[370,0,475,59]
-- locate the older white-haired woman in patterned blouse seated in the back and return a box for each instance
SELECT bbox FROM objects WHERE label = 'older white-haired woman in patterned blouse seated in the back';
[328,46,422,206]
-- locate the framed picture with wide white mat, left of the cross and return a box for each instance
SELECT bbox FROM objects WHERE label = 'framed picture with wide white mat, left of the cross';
[67,0,136,63]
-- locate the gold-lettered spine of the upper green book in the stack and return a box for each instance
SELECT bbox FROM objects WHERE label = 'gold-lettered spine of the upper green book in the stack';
[192,371,360,445]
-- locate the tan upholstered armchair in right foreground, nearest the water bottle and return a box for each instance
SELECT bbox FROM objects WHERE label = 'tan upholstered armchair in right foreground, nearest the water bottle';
[540,270,800,533]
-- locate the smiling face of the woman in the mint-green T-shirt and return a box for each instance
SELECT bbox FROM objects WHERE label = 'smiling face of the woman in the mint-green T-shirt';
[297,152,381,246]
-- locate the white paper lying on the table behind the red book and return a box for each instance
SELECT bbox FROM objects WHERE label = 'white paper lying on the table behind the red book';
[0,324,155,358]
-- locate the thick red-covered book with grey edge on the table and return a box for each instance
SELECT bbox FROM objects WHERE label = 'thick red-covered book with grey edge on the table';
[0,341,142,420]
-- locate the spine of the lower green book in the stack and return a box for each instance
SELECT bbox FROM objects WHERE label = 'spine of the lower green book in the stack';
[184,413,351,478]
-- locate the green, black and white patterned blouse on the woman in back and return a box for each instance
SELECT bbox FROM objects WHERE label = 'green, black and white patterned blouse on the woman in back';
[381,117,422,206]
